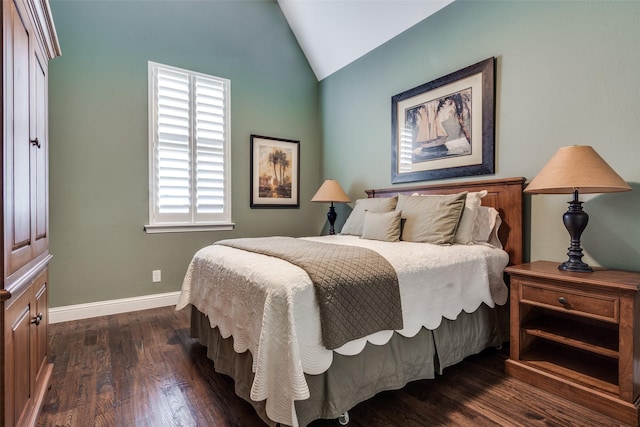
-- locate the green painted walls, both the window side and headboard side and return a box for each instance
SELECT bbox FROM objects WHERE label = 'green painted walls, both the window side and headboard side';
[49,0,640,307]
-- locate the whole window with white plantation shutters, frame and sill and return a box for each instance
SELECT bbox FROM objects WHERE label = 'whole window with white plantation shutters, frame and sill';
[145,62,233,233]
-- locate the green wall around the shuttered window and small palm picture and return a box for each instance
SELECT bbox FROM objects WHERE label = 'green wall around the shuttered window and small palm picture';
[49,0,326,307]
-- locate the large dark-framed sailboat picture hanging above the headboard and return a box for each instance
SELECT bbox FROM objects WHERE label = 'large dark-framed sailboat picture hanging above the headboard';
[391,58,496,184]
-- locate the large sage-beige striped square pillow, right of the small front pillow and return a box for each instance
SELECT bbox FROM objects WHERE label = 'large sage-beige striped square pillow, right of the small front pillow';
[396,191,467,244]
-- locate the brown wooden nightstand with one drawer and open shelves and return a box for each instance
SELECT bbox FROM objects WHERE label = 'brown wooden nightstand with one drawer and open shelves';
[505,261,640,426]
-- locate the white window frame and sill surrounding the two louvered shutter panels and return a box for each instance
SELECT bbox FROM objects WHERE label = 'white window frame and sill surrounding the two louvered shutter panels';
[144,61,235,233]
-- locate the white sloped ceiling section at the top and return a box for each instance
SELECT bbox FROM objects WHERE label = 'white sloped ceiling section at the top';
[278,0,453,80]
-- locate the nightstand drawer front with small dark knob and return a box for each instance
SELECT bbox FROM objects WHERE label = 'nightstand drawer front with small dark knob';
[520,282,619,323]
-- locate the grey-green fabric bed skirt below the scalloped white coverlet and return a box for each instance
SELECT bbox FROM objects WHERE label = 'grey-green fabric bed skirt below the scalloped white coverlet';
[191,304,509,426]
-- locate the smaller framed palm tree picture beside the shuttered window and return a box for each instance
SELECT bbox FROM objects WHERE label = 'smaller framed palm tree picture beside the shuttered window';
[251,135,300,208]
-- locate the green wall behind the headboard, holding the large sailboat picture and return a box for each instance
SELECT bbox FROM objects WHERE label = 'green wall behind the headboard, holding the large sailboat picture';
[320,1,640,270]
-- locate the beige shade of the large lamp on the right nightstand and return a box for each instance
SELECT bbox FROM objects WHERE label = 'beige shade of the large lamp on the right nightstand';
[524,145,631,194]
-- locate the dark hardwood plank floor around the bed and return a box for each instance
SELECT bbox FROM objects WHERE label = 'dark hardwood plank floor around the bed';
[38,307,621,427]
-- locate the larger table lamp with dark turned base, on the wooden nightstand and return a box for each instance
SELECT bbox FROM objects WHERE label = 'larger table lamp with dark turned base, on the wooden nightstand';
[524,145,631,272]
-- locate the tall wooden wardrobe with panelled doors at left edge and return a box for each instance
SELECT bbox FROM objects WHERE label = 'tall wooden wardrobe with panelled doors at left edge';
[0,0,60,427]
